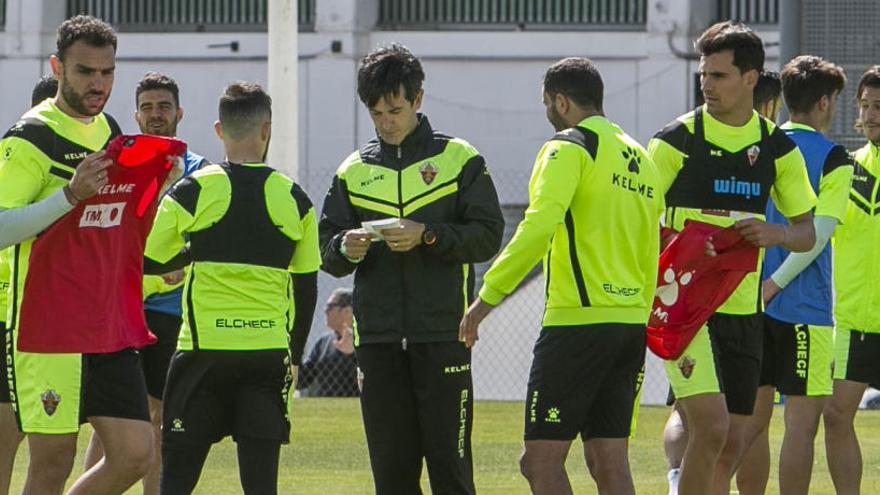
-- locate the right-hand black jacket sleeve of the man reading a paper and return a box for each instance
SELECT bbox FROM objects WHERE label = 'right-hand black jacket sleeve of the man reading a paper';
[422,155,504,263]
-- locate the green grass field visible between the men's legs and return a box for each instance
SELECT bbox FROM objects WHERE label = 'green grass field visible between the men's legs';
[6,399,880,495]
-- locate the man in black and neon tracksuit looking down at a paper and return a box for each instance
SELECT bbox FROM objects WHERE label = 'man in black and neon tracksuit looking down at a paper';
[319,44,504,495]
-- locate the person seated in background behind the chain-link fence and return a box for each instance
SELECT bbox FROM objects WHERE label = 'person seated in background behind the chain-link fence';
[296,288,358,397]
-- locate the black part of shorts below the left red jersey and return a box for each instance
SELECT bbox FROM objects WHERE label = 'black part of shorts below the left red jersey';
[79,349,150,423]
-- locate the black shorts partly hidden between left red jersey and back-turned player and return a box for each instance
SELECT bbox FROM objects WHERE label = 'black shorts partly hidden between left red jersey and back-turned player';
[141,310,182,399]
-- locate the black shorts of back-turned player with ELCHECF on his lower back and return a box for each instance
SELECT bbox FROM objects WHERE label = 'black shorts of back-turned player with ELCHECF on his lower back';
[162,349,292,443]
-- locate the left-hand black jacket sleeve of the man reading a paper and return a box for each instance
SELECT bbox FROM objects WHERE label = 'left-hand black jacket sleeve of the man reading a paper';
[318,175,360,277]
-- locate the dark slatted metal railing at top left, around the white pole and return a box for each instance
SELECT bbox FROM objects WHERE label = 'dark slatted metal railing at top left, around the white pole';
[67,0,316,32]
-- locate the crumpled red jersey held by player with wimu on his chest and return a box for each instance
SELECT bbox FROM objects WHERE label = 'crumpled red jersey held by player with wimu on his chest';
[647,221,758,359]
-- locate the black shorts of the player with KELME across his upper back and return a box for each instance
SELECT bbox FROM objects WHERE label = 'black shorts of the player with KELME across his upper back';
[525,323,645,440]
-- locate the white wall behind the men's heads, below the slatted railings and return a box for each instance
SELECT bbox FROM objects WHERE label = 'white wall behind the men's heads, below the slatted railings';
[0,32,688,202]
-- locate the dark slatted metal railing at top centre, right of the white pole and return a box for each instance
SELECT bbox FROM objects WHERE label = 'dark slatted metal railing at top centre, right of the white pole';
[378,0,647,30]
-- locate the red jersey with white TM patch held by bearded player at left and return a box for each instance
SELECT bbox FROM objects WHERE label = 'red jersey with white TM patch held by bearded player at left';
[18,135,186,354]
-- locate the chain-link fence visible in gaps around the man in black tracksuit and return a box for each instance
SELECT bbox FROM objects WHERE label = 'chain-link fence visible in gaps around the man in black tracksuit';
[301,169,667,404]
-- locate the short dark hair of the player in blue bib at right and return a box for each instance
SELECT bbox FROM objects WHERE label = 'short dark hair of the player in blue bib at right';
[782,55,846,113]
